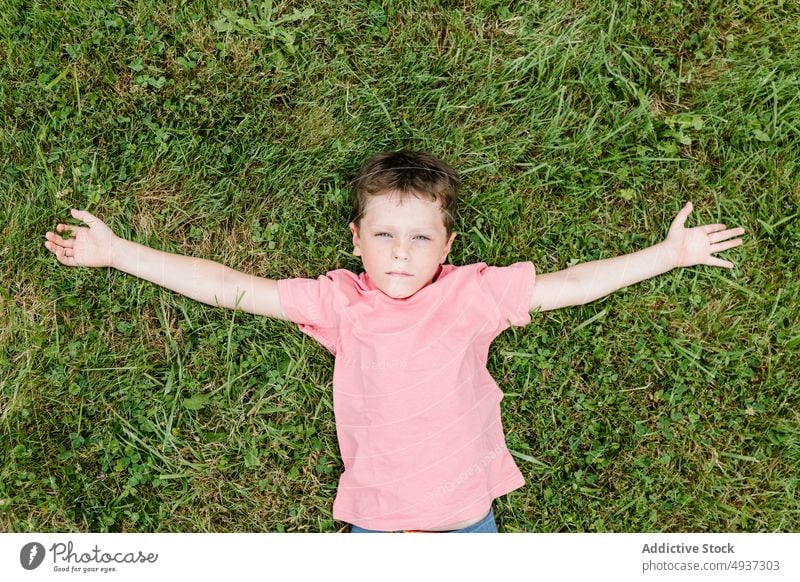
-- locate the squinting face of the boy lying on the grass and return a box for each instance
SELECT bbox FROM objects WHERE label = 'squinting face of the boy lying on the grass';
[350,194,456,299]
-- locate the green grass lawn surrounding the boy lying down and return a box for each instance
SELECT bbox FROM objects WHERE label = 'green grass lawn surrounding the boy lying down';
[0,0,800,532]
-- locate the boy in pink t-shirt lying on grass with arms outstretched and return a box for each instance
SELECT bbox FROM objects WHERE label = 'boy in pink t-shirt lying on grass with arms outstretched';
[45,152,744,532]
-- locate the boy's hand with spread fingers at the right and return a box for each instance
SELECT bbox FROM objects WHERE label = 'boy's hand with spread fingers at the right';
[664,201,744,269]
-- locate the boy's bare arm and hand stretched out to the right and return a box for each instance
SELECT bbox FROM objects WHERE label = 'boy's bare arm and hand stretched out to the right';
[531,202,744,311]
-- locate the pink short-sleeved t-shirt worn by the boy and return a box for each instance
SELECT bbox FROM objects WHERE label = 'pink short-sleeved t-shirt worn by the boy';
[278,262,536,530]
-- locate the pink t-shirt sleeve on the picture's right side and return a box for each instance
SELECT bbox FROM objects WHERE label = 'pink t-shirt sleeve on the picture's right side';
[478,261,536,336]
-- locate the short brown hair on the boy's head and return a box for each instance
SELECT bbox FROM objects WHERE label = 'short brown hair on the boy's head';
[351,150,461,237]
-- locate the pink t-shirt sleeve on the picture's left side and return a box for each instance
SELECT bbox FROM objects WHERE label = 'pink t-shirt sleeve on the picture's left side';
[278,273,339,356]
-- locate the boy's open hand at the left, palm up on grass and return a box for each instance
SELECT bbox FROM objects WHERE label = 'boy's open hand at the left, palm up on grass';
[44,208,119,267]
